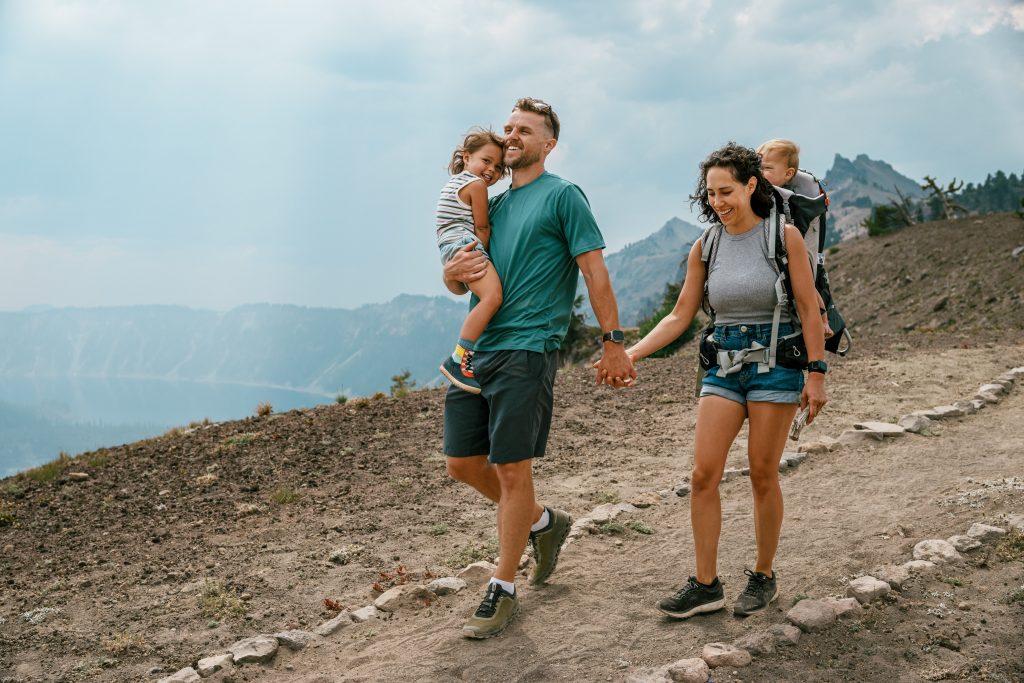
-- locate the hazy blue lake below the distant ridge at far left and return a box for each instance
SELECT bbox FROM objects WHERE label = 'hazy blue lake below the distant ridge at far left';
[0,377,334,477]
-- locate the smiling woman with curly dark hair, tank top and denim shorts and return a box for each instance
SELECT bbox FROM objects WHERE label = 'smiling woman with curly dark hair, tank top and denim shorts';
[602,142,826,618]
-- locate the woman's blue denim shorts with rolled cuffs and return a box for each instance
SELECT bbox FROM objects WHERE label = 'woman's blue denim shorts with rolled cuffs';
[700,323,804,405]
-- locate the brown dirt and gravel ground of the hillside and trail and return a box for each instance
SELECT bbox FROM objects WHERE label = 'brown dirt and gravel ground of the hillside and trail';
[0,210,1024,683]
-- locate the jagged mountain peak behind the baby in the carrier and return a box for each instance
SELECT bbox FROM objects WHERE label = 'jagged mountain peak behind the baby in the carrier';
[823,155,925,245]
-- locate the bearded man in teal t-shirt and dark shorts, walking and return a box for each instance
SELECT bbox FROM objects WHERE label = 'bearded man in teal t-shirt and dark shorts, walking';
[444,97,636,638]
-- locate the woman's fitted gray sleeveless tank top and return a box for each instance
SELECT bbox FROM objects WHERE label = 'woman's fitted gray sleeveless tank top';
[708,221,790,325]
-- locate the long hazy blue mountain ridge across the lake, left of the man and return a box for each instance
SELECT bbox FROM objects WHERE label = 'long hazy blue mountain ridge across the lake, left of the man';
[0,295,466,394]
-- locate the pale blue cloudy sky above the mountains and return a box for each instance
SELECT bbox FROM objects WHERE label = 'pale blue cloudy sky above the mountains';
[0,0,1024,310]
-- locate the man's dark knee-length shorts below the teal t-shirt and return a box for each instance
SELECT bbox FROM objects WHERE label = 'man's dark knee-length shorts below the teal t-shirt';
[444,350,558,464]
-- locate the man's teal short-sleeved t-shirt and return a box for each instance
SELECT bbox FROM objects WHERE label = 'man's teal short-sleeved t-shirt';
[470,172,604,351]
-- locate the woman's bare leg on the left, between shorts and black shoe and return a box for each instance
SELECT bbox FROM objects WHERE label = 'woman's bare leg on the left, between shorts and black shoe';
[690,395,746,584]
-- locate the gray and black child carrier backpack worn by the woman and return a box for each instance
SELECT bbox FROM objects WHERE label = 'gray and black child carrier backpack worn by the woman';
[699,171,853,385]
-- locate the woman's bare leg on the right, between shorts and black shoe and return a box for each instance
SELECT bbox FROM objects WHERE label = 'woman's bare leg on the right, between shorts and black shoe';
[746,401,797,577]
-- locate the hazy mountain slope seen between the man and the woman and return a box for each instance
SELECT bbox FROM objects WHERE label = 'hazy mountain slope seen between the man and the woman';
[579,218,701,327]
